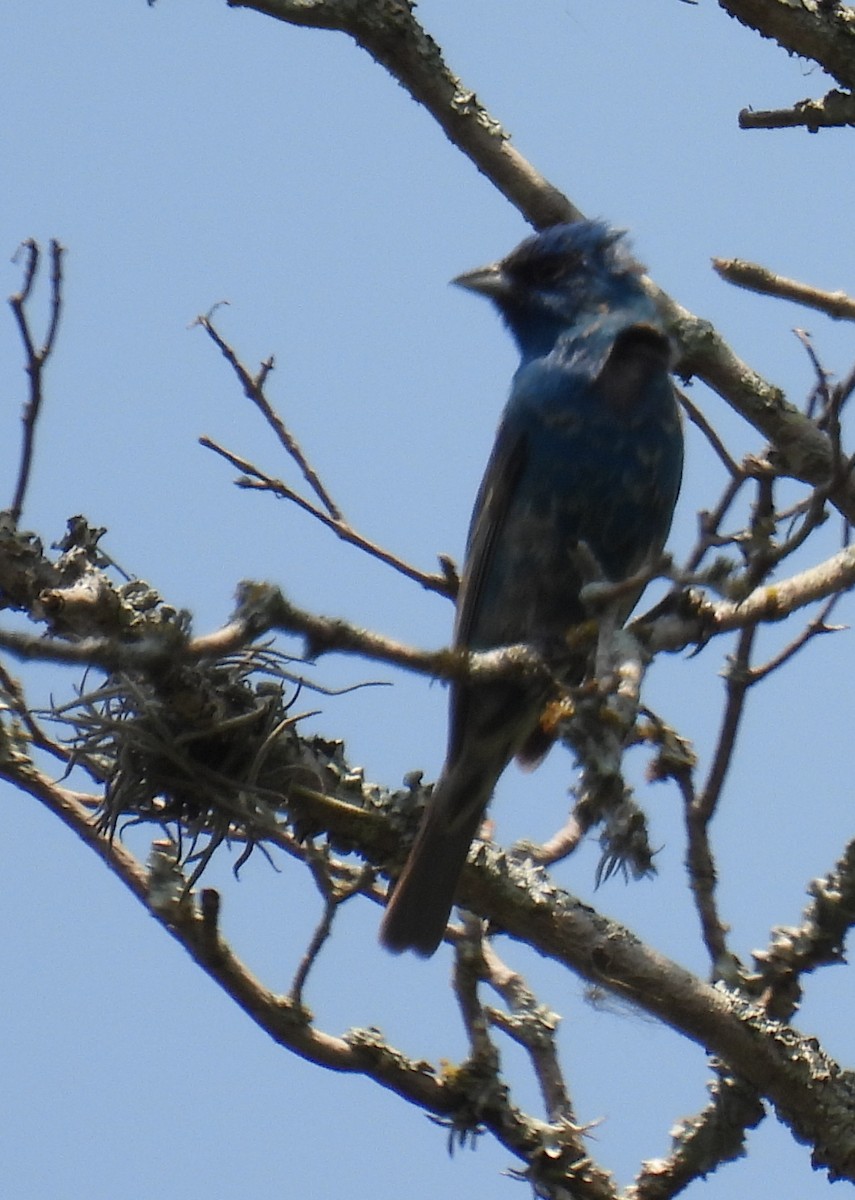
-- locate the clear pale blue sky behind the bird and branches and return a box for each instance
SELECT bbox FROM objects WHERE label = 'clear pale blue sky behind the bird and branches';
[0,0,855,1200]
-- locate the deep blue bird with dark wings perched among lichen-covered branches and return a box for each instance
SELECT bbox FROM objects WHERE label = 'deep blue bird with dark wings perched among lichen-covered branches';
[381,221,683,958]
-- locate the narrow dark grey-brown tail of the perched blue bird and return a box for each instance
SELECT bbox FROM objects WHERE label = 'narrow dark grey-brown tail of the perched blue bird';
[379,768,495,959]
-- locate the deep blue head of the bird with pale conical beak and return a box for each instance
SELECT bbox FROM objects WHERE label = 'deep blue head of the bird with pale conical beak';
[452,221,648,358]
